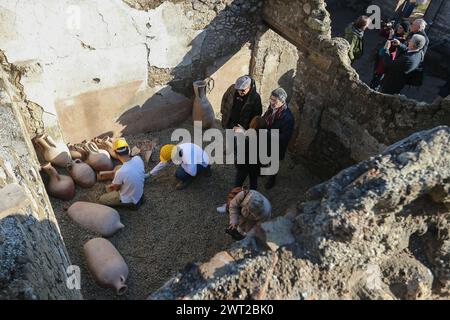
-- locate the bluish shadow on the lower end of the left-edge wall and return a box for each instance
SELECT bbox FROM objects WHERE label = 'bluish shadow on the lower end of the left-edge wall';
[0,212,82,300]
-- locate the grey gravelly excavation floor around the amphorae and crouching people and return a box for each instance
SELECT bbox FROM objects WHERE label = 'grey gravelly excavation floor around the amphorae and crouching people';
[51,122,320,299]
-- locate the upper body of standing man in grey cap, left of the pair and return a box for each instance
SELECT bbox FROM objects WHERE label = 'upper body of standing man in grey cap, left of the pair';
[221,76,262,130]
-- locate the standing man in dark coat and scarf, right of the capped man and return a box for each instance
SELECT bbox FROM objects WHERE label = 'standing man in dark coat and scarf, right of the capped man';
[263,88,295,189]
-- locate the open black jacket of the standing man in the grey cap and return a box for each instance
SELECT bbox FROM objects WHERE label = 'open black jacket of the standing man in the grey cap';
[221,79,262,129]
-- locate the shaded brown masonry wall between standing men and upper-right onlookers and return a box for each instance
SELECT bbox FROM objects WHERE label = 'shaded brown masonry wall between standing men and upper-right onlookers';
[258,0,450,177]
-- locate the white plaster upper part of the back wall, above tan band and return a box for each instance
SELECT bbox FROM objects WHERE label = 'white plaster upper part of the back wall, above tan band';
[0,0,204,138]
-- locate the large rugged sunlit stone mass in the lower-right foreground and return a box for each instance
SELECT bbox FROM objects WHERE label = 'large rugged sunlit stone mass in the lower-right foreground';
[152,127,450,300]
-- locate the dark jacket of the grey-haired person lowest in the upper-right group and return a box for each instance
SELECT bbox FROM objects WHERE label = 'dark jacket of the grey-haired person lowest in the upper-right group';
[381,48,424,94]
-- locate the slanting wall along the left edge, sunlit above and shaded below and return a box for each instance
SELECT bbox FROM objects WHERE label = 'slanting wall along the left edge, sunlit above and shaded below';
[0,56,81,300]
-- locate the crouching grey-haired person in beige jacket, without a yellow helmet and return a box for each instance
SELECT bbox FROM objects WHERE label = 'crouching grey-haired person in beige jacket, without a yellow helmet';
[225,188,272,240]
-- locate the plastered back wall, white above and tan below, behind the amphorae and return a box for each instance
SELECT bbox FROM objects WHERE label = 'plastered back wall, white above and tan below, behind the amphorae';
[0,0,262,142]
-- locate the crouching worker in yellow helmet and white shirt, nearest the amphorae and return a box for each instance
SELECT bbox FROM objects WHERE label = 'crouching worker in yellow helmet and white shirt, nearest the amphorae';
[99,138,145,210]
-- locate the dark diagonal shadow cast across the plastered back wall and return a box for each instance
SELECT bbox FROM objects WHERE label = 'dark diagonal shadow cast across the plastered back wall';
[117,0,260,136]
